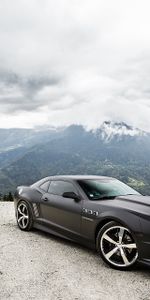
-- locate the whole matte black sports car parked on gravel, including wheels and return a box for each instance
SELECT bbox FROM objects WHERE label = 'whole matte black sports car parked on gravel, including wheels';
[14,176,150,269]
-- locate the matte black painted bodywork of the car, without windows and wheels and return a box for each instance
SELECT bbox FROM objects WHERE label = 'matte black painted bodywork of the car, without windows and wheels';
[14,176,150,264]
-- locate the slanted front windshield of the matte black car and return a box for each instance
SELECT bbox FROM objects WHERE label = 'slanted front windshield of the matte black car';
[78,179,140,200]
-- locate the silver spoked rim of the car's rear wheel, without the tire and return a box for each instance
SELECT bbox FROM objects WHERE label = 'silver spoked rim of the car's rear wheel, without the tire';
[17,202,29,229]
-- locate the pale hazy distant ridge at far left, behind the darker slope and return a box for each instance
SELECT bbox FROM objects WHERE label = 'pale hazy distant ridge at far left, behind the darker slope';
[0,127,63,168]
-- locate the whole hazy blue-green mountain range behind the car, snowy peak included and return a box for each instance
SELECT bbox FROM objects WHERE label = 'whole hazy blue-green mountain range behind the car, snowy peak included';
[0,121,150,194]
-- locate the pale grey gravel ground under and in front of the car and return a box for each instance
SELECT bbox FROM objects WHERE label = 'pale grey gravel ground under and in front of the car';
[0,202,150,300]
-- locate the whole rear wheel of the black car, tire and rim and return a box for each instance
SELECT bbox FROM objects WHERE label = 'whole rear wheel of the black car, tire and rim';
[16,200,33,231]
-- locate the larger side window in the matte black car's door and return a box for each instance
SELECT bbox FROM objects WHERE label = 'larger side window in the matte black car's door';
[48,181,77,196]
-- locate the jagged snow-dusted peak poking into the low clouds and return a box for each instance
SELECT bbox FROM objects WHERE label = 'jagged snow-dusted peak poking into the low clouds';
[96,121,148,142]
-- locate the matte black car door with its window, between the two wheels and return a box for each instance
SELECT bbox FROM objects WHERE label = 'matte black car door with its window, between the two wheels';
[41,180,82,235]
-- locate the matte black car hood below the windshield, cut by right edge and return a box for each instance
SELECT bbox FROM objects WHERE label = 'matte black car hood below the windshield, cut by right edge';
[115,195,150,206]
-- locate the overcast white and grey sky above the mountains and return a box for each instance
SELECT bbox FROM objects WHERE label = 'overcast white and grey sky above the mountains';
[0,0,150,131]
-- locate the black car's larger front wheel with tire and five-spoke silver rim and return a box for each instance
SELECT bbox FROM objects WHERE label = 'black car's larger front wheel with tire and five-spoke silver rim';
[97,221,138,270]
